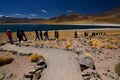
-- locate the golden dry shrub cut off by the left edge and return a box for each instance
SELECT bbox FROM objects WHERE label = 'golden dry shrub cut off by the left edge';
[0,53,14,65]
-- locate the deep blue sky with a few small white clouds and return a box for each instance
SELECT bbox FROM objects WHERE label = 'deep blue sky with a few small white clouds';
[0,0,120,18]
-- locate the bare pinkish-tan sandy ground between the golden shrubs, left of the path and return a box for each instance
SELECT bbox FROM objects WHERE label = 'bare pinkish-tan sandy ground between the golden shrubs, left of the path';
[0,52,35,78]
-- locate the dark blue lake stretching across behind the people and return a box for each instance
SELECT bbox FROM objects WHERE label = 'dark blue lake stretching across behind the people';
[0,24,120,32]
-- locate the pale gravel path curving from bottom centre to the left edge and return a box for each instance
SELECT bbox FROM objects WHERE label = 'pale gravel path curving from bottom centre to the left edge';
[0,44,82,80]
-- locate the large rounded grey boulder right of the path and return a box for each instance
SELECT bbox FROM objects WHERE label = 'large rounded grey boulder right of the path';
[78,56,96,71]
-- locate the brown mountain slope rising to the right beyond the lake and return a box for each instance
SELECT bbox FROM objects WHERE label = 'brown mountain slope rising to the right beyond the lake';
[41,7,120,24]
